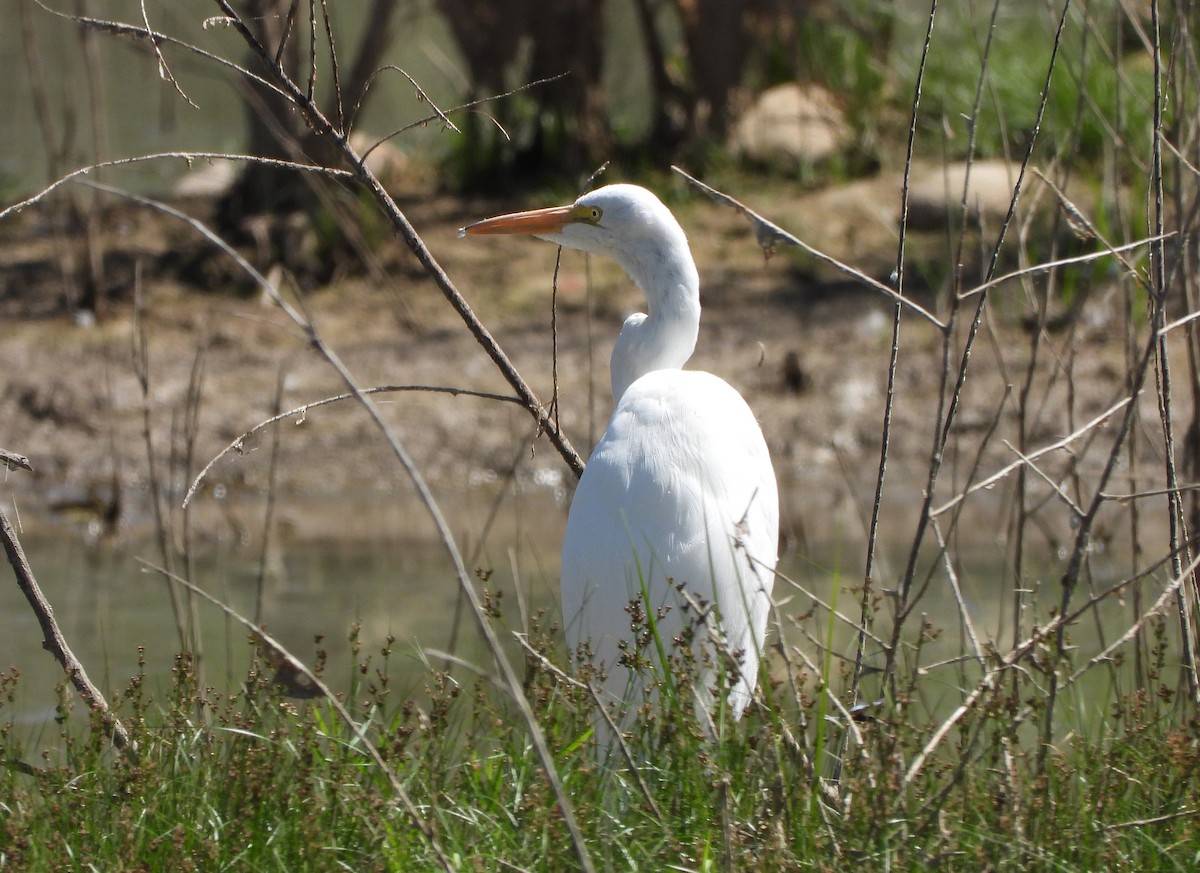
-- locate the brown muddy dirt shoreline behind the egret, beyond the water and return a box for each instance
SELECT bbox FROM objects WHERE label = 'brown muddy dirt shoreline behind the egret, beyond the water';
[0,178,1152,558]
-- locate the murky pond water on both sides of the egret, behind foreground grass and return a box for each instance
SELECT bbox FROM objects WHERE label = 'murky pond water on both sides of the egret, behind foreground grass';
[0,492,1161,745]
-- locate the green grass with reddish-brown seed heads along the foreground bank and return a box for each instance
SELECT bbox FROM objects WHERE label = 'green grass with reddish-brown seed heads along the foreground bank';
[0,606,1200,871]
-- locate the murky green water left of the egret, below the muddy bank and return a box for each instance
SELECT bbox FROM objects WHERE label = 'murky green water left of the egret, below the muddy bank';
[0,495,563,739]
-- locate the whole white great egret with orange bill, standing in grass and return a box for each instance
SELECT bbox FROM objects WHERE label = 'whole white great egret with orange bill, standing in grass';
[463,185,779,717]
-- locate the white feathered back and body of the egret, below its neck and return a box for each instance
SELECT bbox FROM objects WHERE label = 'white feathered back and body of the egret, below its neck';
[563,369,779,715]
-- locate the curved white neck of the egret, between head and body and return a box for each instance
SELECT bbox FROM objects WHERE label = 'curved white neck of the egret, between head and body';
[611,230,700,402]
